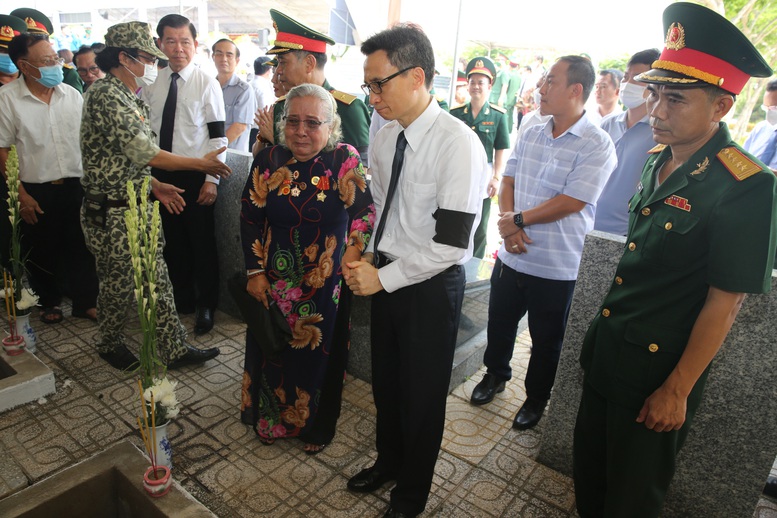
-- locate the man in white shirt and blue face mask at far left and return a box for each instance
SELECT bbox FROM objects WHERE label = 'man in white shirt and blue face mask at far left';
[0,34,97,324]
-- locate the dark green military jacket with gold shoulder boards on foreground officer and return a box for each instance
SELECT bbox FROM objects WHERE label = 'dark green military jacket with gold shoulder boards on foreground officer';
[580,123,777,416]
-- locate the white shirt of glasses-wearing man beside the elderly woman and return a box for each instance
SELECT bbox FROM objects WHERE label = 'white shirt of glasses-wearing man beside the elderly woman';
[367,98,488,293]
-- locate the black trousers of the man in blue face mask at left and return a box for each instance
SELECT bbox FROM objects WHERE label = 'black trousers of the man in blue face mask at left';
[21,178,98,311]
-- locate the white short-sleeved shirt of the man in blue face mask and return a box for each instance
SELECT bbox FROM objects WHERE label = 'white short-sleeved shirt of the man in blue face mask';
[0,77,84,183]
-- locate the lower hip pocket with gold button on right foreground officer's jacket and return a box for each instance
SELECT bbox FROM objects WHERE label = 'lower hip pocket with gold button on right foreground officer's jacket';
[615,320,690,399]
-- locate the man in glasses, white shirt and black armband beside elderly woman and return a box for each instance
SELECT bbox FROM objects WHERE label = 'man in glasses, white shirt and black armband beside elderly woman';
[344,25,488,517]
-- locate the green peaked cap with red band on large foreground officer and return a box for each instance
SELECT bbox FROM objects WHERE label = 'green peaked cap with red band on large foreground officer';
[634,2,772,95]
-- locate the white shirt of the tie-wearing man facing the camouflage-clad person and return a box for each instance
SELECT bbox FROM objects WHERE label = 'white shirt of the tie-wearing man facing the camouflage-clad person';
[140,63,227,183]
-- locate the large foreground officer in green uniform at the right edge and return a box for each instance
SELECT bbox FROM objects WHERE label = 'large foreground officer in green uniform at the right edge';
[574,3,777,518]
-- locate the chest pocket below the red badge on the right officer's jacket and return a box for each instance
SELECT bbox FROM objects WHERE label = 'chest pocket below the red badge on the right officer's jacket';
[643,208,705,270]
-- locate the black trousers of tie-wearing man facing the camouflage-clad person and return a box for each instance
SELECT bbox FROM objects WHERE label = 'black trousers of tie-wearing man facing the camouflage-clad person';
[153,169,219,312]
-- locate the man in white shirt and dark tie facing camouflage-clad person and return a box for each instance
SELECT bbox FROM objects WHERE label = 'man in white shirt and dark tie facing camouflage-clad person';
[142,14,227,334]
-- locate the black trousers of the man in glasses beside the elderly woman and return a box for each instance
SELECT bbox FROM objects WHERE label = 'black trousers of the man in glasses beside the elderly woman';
[370,266,465,514]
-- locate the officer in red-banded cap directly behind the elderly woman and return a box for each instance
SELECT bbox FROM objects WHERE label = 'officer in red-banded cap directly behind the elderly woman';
[258,9,370,163]
